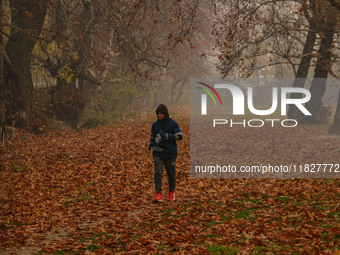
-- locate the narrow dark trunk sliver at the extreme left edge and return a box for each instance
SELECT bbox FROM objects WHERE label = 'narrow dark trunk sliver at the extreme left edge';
[0,0,6,146]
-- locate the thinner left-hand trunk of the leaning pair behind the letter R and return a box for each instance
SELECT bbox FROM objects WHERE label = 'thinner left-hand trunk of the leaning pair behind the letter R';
[288,20,317,119]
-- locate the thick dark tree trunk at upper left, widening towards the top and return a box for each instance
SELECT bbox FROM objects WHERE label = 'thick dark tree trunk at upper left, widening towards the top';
[5,0,48,128]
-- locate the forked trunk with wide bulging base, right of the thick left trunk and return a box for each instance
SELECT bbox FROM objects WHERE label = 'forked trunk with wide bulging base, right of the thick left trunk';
[47,0,93,129]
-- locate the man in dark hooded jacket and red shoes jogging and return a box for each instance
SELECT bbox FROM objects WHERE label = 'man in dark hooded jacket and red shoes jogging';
[149,104,183,203]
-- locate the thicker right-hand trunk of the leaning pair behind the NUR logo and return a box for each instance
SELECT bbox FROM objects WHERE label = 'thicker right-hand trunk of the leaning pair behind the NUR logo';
[304,12,337,123]
